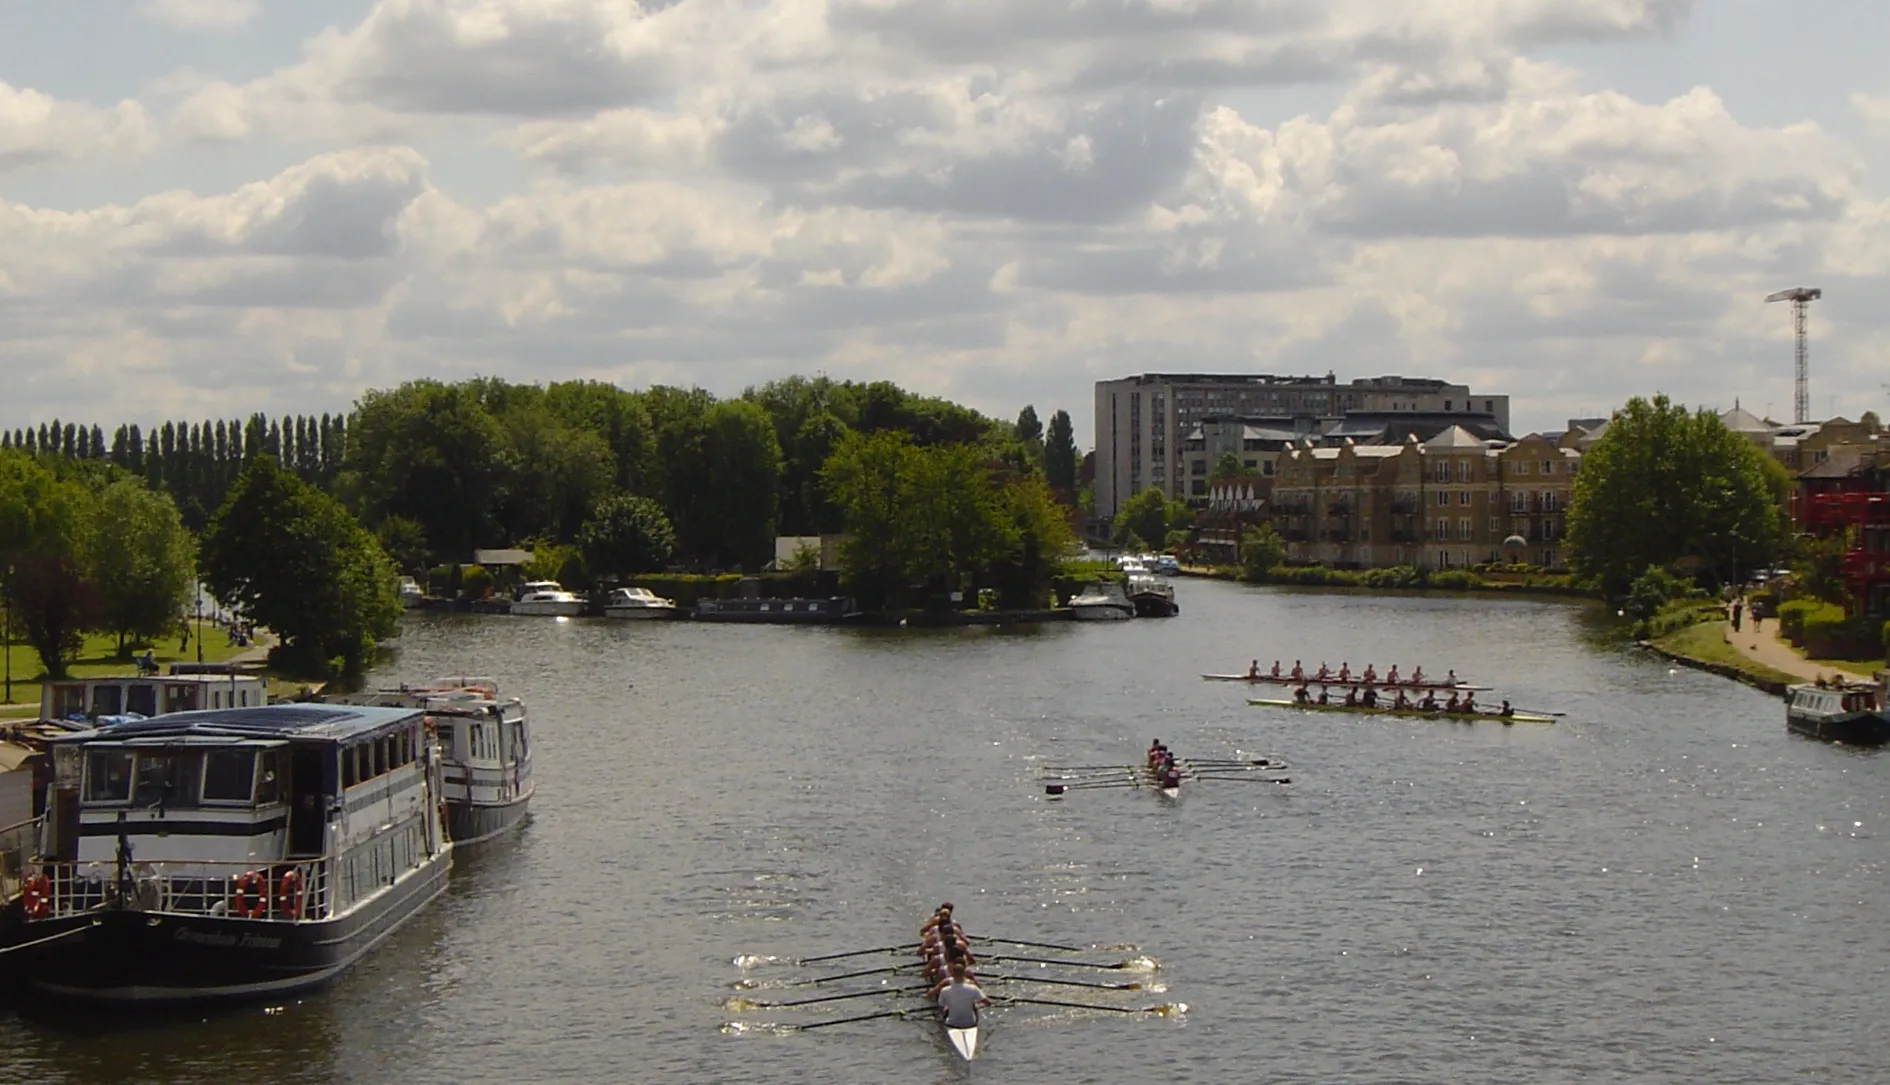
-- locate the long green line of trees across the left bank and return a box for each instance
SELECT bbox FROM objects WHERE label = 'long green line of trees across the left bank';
[0,376,1077,675]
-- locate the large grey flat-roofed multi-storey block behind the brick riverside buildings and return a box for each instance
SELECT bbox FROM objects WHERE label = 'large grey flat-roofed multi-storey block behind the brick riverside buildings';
[1094,372,1510,518]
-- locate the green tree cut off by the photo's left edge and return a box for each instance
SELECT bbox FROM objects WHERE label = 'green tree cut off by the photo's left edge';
[0,450,98,679]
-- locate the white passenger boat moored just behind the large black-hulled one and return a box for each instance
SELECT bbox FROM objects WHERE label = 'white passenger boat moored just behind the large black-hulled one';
[323,677,537,847]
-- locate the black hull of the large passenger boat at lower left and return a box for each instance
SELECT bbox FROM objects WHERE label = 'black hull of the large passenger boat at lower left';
[19,851,452,1006]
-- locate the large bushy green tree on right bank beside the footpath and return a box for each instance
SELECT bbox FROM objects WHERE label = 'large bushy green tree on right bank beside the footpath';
[1567,395,1790,597]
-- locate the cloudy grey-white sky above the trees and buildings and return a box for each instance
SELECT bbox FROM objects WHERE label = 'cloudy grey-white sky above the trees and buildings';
[0,0,1890,446]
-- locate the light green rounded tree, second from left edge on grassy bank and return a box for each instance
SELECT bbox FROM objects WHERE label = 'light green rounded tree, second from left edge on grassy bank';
[91,476,197,658]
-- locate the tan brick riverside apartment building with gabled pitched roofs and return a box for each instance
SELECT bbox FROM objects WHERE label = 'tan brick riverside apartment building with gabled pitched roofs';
[1272,427,1580,569]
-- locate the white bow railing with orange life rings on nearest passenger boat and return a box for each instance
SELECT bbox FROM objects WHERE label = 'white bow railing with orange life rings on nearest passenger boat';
[26,860,333,922]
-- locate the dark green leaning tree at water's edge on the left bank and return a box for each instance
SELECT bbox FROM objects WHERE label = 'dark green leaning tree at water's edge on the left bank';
[202,456,401,673]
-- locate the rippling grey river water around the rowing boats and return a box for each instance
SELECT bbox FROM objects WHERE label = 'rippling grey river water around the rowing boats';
[0,580,1890,1085]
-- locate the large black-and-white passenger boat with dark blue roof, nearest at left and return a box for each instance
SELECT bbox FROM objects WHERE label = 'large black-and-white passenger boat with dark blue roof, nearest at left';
[15,705,452,1006]
